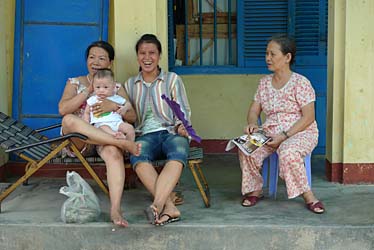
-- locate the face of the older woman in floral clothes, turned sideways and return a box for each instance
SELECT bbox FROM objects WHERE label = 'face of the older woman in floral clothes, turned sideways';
[266,41,291,72]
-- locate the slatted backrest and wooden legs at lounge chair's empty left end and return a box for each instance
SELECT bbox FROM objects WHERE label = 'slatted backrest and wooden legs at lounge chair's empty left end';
[0,112,109,211]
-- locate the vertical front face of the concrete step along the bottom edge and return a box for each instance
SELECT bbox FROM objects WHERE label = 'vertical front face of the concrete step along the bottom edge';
[0,222,374,250]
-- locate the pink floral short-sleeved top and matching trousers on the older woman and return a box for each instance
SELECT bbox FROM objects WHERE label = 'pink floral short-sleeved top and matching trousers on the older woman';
[239,73,318,198]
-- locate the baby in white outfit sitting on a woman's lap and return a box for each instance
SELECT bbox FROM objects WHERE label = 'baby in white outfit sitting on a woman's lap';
[84,69,135,141]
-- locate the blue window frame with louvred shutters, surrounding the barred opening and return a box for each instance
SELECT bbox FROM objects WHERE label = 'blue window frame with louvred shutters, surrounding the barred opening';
[168,0,328,75]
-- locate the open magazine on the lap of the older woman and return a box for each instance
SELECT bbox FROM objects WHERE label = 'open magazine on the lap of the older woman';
[226,130,271,156]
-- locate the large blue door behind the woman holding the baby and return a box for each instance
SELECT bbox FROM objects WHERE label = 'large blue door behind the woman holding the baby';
[12,0,109,136]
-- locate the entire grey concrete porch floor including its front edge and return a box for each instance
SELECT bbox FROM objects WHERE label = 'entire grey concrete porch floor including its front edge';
[0,155,374,250]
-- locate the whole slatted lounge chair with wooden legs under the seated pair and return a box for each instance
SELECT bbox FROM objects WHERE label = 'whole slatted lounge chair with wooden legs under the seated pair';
[0,112,210,211]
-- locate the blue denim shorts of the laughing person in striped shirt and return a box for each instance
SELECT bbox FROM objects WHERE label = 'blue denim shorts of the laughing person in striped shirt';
[130,130,190,169]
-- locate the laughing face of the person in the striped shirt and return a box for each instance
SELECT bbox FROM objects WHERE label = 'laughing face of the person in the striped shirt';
[138,43,160,73]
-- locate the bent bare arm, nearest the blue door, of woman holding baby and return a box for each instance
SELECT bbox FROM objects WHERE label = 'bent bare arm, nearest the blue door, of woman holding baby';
[58,80,89,116]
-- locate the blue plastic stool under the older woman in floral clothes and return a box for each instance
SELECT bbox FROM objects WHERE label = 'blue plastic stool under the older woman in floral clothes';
[262,152,312,199]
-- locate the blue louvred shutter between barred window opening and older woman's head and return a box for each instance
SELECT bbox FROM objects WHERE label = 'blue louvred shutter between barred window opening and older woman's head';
[237,0,288,71]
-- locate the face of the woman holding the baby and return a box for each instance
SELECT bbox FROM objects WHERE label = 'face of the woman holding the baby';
[87,47,112,75]
